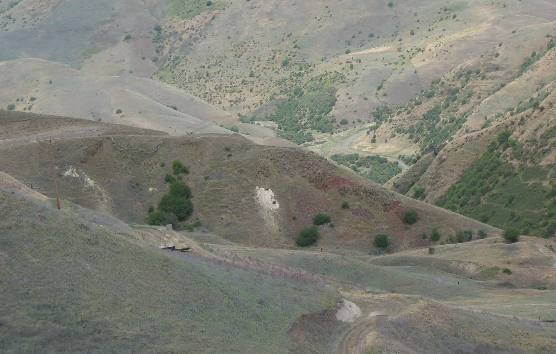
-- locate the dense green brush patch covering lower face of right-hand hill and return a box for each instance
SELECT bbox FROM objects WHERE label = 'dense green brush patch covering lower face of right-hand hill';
[438,131,556,236]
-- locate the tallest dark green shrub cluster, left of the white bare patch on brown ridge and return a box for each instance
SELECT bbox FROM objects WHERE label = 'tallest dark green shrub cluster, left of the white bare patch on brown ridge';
[147,161,193,227]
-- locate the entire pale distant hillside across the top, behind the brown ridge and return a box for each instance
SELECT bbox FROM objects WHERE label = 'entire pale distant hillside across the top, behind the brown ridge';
[0,0,556,144]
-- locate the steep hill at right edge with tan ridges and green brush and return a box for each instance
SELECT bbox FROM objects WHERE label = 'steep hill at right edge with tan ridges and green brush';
[376,37,556,237]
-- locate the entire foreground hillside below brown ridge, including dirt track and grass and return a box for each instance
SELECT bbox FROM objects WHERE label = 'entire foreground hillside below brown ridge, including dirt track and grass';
[0,167,556,353]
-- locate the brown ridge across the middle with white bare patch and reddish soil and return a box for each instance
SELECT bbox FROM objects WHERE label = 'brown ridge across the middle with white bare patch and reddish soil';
[0,112,497,252]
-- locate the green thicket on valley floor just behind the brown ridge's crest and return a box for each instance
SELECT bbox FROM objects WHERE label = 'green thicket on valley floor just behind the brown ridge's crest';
[331,154,402,184]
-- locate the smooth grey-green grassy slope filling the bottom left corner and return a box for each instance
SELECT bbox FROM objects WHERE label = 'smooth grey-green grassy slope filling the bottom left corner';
[0,175,335,353]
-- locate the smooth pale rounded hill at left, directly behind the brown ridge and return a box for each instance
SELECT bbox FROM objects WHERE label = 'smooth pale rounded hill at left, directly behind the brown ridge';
[0,59,230,135]
